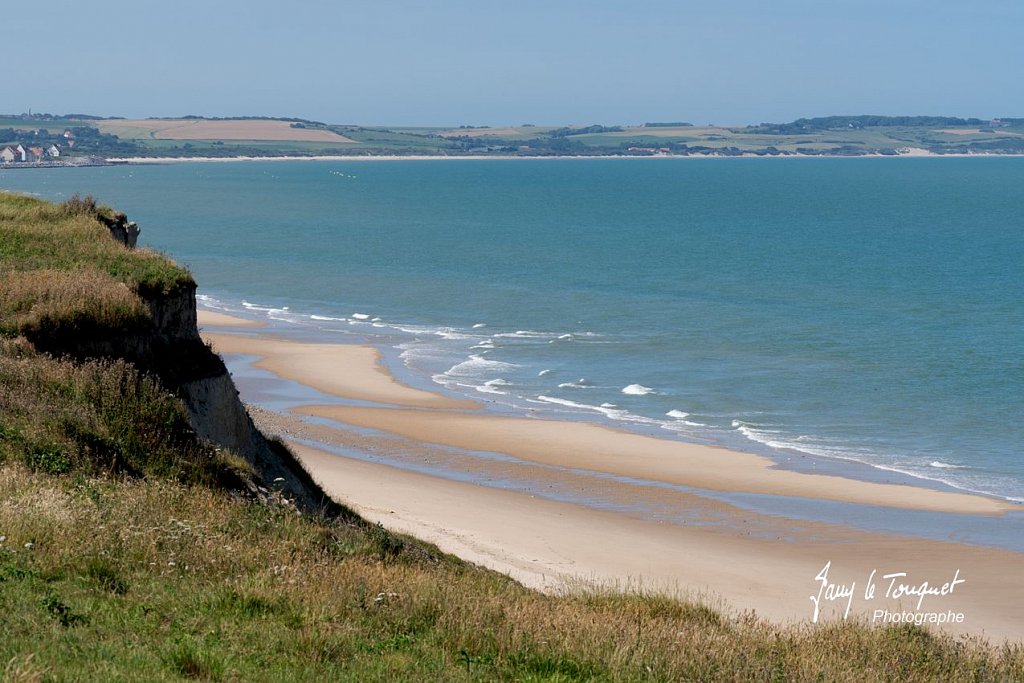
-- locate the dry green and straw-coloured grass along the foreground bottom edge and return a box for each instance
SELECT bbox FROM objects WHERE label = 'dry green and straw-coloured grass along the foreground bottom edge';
[0,465,1024,681]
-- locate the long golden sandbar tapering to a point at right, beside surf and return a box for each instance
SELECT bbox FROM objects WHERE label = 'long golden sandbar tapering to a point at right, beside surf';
[292,405,1019,515]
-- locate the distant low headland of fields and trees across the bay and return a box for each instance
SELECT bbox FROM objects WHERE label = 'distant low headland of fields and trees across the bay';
[0,114,1024,168]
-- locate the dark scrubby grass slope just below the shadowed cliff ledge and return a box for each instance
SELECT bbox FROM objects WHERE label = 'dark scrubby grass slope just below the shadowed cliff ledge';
[0,340,249,485]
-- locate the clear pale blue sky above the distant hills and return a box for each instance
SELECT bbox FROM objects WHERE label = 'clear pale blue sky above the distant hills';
[9,0,1024,125]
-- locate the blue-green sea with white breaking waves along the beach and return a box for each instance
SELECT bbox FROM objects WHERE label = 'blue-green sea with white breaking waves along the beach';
[0,158,1024,500]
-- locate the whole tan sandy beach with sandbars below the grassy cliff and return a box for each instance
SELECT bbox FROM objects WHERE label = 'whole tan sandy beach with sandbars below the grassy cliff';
[201,313,1024,639]
